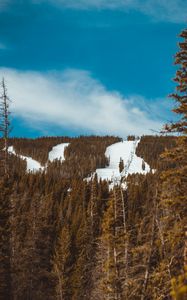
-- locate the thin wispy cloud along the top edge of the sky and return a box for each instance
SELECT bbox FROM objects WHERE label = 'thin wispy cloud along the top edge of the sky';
[41,0,187,23]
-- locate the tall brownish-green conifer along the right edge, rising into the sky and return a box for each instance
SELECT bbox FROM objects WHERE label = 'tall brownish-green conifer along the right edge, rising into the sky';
[160,29,187,293]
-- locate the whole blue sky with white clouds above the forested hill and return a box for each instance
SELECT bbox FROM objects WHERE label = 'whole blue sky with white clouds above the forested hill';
[0,0,187,137]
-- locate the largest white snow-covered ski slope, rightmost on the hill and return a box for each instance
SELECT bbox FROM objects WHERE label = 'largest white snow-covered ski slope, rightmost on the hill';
[96,141,150,183]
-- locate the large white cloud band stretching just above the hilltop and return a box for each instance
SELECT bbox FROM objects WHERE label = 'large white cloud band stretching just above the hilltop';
[0,68,162,136]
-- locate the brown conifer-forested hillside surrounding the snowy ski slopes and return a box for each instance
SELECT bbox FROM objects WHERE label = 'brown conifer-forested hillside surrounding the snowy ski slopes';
[0,136,183,300]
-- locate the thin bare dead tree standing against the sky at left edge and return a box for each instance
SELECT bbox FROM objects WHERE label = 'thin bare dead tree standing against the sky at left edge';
[0,78,11,176]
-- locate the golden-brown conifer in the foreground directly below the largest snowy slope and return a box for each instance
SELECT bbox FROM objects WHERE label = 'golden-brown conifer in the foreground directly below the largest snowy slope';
[94,187,128,300]
